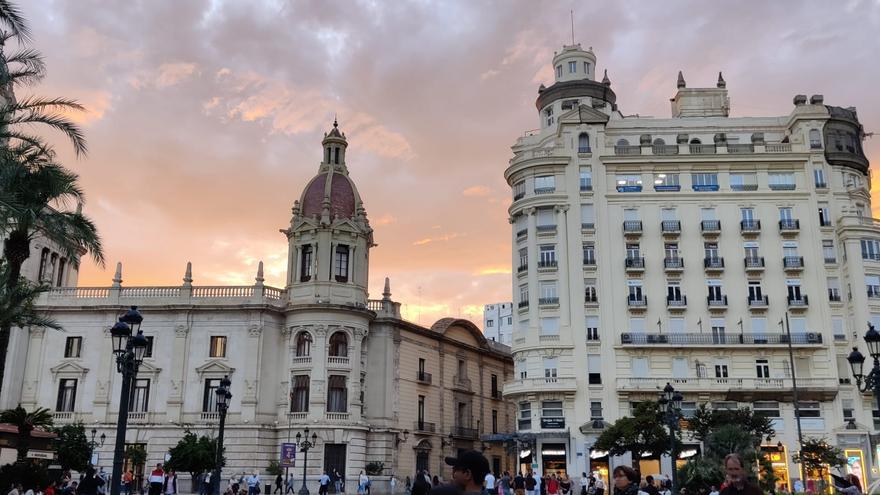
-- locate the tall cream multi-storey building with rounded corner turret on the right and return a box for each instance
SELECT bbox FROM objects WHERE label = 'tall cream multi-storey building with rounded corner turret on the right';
[504,45,880,486]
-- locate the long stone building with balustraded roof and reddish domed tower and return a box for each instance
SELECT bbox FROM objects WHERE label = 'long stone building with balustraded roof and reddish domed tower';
[4,123,513,489]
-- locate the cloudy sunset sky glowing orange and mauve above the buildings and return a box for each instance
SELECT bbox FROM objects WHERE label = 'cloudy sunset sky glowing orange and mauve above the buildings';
[20,0,880,325]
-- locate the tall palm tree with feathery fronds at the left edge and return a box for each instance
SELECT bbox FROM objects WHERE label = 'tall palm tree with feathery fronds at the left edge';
[0,0,95,400]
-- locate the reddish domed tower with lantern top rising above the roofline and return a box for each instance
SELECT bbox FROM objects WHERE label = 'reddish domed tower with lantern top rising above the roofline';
[282,120,373,307]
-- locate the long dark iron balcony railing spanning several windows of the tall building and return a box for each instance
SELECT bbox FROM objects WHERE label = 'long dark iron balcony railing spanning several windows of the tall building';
[620,332,822,346]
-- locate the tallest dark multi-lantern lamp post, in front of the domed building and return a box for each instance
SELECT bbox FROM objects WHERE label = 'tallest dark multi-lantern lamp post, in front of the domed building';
[110,306,147,495]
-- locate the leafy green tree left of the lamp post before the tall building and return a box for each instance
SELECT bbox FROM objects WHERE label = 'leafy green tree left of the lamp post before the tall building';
[593,402,669,471]
